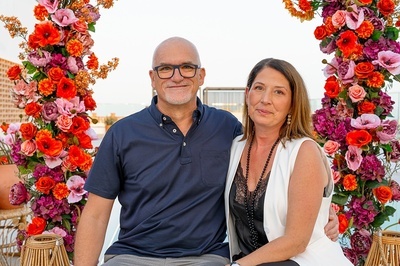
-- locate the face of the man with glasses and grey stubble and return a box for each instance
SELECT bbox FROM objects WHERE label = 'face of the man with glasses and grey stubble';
[149,42,205,105]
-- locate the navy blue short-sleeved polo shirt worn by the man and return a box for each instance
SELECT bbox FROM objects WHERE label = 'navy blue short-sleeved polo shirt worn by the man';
[85,97,242,258]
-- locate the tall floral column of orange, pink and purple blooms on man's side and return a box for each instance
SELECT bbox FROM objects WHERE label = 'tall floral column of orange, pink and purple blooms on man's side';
[0,0,118,261]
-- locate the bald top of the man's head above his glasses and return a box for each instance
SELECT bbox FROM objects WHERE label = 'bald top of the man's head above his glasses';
[152,37,201,67]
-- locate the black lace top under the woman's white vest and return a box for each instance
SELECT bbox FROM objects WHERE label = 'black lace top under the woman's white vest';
[229,163,270,255]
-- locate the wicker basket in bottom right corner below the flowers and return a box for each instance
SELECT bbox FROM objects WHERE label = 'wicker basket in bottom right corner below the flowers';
[365,231,400,266]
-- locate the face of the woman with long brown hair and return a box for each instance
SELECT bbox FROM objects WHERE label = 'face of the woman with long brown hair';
[246,67,292,131]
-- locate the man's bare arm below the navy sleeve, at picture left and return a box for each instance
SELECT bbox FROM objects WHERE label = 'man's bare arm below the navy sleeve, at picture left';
[74,193,114,266]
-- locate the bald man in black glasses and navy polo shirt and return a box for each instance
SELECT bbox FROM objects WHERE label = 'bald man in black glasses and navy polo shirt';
[74,37,337,266]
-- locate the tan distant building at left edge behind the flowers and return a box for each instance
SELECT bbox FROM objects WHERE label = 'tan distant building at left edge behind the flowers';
[0,58,25,124]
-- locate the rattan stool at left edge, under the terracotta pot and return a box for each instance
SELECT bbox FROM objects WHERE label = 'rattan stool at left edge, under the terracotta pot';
[0,206,31,266]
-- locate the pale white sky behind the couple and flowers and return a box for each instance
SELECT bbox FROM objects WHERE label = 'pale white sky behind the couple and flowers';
[0,0,332,105]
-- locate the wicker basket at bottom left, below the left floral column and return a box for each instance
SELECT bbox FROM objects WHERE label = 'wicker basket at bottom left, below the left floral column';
[21,234,70,266]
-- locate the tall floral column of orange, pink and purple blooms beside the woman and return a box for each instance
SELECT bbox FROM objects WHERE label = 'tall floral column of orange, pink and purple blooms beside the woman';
[283,0,400,266]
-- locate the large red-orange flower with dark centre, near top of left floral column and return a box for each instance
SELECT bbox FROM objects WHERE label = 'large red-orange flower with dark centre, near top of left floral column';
[31,21,61,47]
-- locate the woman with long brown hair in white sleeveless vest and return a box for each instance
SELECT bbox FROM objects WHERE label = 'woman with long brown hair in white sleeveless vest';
[225,58,352,266]
